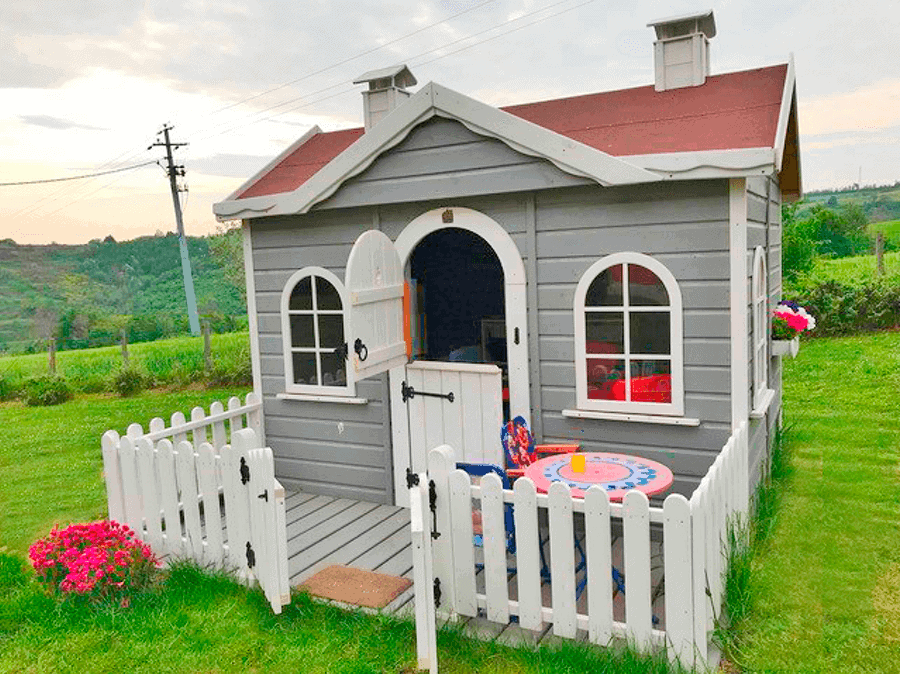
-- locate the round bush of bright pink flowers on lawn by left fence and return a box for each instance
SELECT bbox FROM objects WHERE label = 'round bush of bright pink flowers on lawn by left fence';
[28,520,160,606]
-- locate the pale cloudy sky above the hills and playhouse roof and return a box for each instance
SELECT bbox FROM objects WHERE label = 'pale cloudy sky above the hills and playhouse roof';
[0,0,900,243]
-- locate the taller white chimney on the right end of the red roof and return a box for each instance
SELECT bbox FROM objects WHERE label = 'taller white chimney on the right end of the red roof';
[647,10,716,91]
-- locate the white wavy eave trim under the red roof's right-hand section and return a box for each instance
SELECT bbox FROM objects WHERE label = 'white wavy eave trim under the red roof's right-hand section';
[623,147,775,180]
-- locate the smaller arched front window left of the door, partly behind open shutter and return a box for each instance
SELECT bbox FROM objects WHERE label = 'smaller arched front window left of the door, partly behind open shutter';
[281,267,353,395]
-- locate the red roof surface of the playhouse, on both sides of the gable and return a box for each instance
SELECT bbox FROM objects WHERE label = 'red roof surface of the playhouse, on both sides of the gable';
[237,65,787,199]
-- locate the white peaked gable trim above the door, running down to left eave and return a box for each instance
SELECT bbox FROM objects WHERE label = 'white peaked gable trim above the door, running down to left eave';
[213,82,661,220]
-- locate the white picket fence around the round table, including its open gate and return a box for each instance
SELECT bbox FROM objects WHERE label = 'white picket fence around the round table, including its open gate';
[410,424,748,671]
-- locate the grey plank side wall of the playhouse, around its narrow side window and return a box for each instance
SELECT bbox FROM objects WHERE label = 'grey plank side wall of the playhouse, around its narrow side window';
[747,176,782,489]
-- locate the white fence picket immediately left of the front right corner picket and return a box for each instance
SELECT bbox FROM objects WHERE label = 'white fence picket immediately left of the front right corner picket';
[622,489,653,651]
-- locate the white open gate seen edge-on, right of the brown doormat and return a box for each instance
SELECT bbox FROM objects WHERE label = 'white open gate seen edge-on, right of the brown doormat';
[409,473,438,673]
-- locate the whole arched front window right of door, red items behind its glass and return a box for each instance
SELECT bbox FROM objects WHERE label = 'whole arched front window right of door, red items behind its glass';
[574,252,684,415]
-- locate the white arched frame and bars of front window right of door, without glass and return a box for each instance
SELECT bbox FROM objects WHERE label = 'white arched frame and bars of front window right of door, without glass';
[574,252,684,416]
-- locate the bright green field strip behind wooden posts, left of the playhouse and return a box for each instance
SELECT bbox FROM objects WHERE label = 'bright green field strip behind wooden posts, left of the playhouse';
[0,332,250,393]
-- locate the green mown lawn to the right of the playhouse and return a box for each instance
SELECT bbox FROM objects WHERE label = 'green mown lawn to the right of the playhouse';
[739,332,900,673]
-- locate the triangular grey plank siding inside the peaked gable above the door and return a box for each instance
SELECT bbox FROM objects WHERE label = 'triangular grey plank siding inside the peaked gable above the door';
[318,117,593,210]
